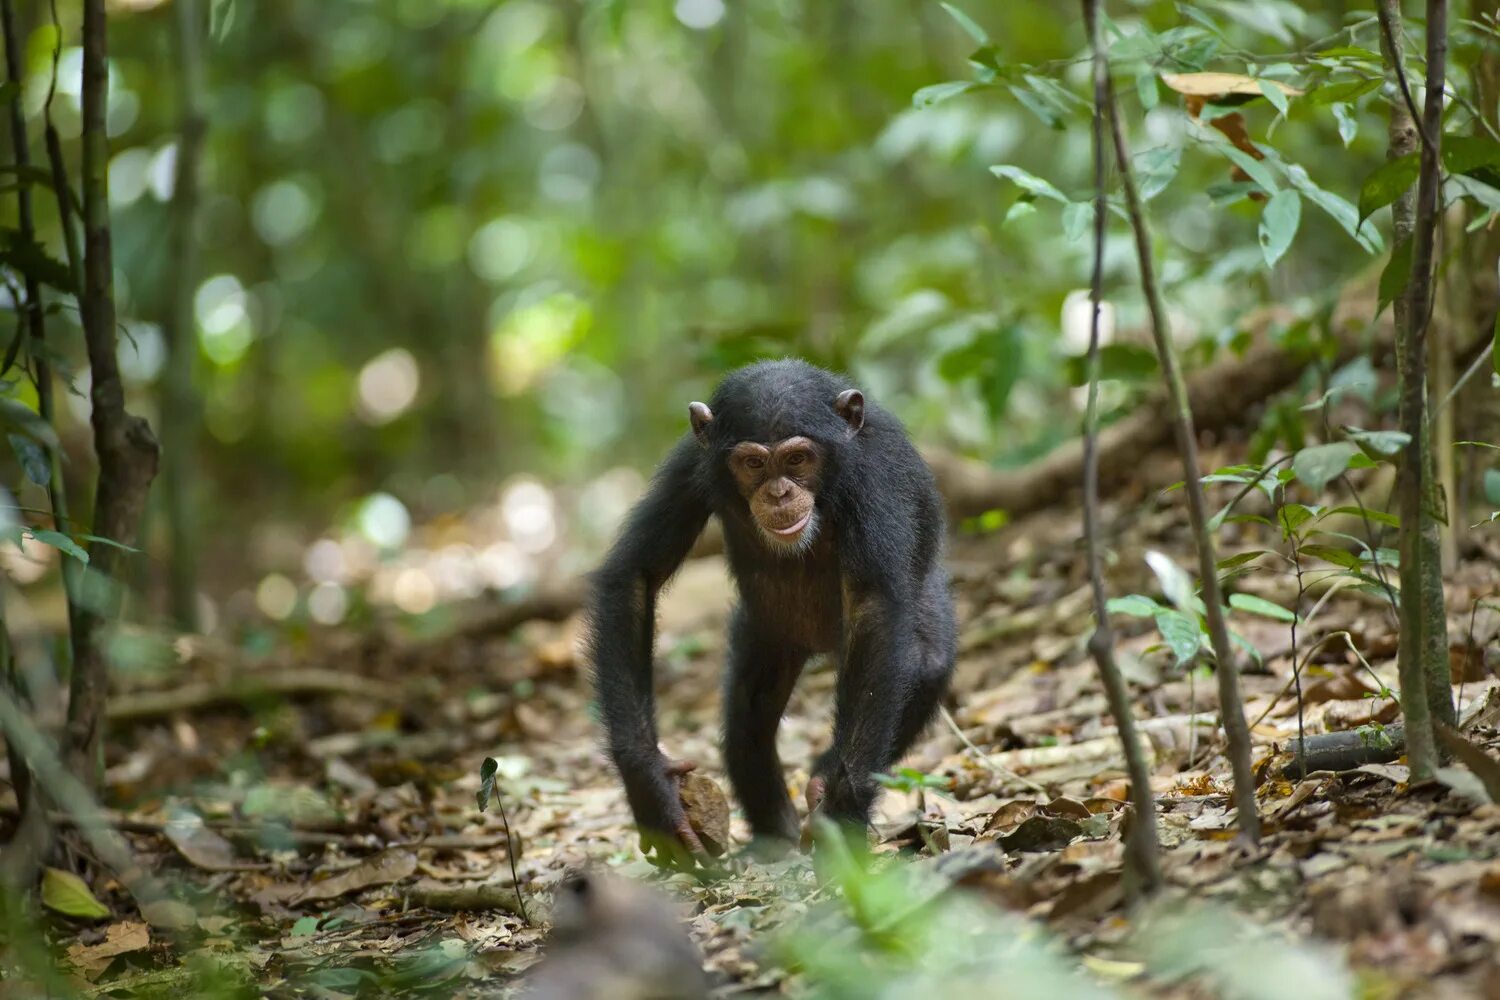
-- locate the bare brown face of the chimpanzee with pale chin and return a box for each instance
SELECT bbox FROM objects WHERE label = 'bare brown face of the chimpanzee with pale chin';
[729,436,824,550]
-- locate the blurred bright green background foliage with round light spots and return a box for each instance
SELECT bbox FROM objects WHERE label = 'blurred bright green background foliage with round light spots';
[0,0,1493,632]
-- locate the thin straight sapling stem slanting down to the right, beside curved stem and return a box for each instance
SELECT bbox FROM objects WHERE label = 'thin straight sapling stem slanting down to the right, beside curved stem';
[1106,75,1260,844]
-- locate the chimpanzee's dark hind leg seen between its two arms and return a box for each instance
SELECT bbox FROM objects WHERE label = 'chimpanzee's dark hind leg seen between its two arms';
[725,609,807,841]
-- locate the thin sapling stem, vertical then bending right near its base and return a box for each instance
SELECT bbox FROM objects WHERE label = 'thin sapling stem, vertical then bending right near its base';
[1083,0,1161,894]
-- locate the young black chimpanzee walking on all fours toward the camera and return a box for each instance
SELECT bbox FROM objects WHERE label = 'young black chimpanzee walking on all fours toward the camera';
[588,360,956,864]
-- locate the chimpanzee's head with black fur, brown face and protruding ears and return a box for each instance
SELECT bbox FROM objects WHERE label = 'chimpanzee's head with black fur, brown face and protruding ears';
[687,360,864,553]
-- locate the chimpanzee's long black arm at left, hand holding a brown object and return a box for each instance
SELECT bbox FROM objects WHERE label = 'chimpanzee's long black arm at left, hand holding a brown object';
[588,436,711,864]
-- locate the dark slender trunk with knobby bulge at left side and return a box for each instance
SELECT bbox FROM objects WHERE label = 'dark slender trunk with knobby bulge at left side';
[65,0,158,789]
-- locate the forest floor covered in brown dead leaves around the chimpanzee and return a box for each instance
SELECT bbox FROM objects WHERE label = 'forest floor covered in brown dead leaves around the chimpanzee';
[0,446,1500,997]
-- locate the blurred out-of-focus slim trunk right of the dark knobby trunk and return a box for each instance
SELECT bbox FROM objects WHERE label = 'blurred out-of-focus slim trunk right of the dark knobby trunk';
[162,0,207,631]
